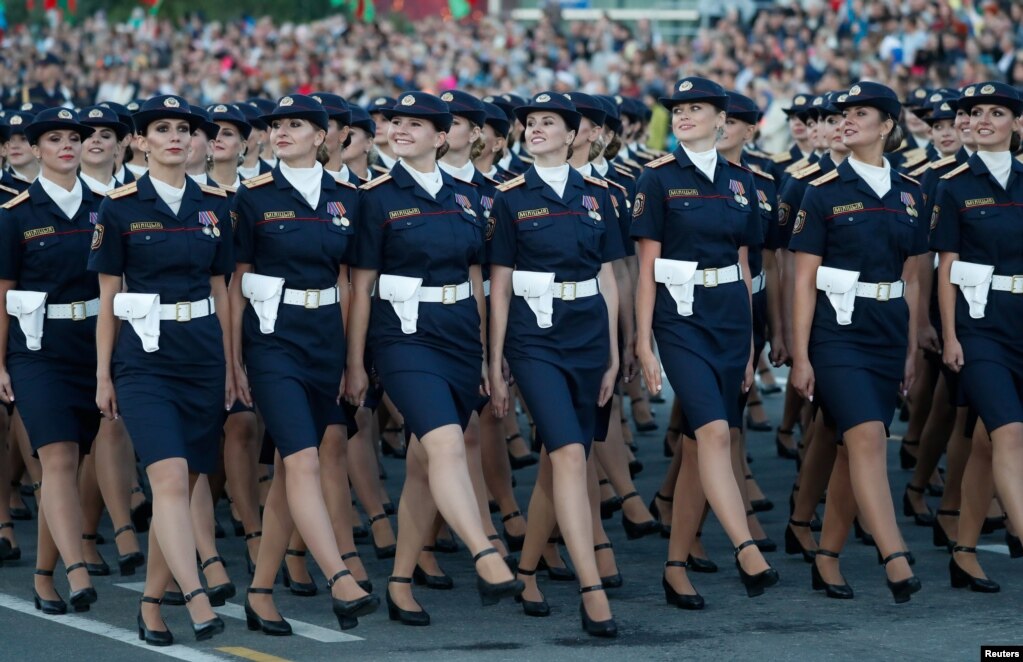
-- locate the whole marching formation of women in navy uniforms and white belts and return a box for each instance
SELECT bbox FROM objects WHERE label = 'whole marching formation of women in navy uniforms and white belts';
[0,77,1023,646]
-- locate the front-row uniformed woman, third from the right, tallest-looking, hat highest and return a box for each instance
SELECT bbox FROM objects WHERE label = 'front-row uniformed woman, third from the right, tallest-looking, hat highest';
[632,78,777,609]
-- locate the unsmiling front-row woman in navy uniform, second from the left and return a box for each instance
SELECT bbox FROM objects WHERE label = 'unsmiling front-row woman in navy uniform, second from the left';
[89,95,234,646]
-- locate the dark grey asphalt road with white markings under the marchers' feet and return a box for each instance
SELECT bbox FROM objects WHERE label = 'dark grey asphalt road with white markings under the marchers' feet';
[0,378,1023,662]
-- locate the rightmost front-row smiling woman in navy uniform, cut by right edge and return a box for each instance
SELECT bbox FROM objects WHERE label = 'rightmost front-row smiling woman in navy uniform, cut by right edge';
[931,83,1023,592]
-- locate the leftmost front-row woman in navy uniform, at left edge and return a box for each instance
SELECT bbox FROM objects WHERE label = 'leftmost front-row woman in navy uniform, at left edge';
[0,108,101,614]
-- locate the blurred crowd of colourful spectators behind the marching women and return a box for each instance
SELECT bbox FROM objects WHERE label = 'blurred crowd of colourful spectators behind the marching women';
[0,0,1023,147]
